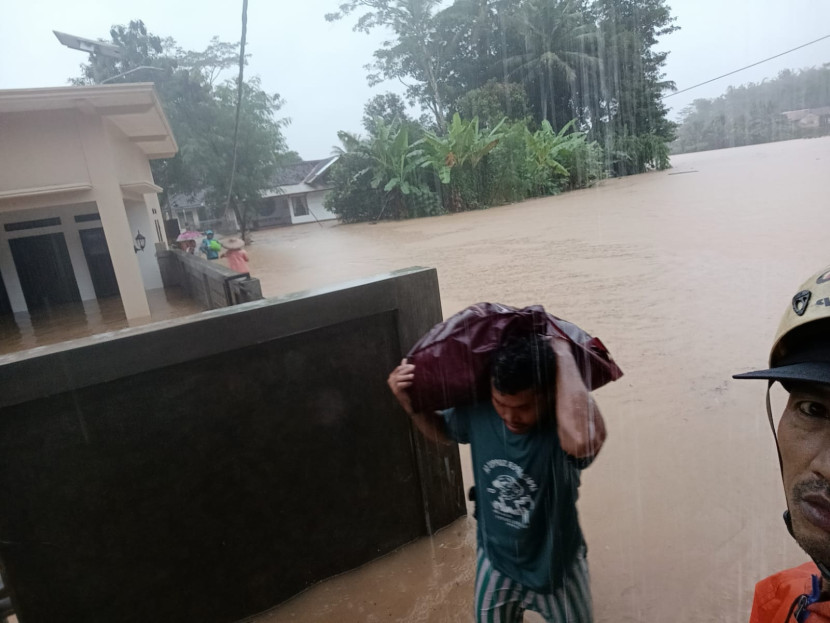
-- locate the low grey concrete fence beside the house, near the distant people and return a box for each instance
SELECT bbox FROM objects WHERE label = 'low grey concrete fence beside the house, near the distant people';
[156,248,262,309]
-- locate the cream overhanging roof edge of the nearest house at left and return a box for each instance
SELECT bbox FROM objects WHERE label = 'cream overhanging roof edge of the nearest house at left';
[0,82,179,159]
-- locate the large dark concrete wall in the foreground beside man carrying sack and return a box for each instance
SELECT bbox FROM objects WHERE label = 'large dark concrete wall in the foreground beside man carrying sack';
[0,269,464,623]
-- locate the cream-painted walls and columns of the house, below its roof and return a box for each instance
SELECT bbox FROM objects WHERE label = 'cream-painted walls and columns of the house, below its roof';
[0,105,166,319]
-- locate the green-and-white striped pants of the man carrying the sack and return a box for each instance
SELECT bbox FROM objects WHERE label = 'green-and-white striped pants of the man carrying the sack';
[475,548,593,623]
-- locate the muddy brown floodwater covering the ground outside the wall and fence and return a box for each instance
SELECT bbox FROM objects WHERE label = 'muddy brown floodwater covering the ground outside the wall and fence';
[240,138,830,623]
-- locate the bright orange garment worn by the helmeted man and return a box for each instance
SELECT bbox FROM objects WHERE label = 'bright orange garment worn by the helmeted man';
[749,562,830,623]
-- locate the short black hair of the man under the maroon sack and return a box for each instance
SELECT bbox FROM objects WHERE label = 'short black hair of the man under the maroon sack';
[491,333,556,395]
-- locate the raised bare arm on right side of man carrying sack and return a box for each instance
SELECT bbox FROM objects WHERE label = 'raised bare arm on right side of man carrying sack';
[551,337,607,459]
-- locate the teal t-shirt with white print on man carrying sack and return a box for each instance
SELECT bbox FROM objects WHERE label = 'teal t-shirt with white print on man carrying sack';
[443,402,585,593]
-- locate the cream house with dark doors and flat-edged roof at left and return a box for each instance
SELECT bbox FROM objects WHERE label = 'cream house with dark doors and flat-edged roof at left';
[0,83,178,319]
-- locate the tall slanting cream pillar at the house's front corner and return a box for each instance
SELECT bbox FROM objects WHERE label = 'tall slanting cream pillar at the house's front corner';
[78,114,150,320]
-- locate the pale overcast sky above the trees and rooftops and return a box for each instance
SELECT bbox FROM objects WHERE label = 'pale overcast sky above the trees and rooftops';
[0,0,830,159]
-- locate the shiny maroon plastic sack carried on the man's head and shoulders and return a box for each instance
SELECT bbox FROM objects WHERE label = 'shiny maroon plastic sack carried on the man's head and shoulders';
[406,303,623,412]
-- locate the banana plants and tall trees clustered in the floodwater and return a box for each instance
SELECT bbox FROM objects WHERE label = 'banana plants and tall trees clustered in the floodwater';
[327,0,676,222]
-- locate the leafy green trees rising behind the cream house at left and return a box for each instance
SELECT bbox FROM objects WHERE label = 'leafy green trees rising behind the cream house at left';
[73,20,296,236]
